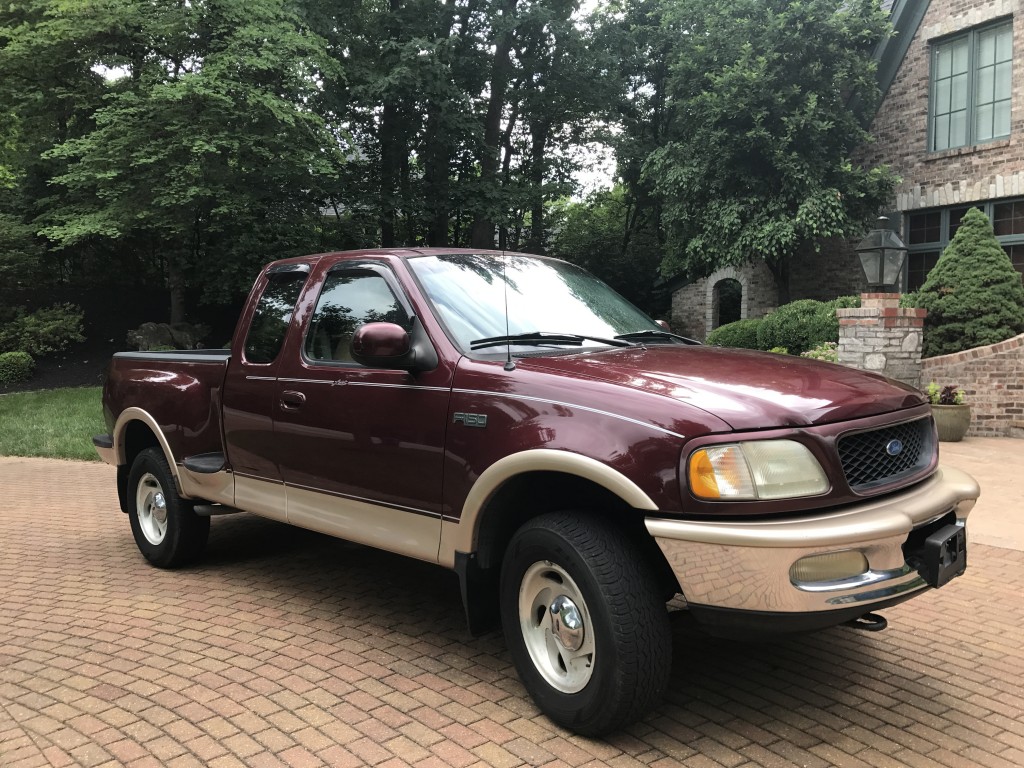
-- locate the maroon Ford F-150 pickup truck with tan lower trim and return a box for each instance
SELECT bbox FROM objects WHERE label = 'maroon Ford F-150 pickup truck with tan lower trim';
[93,249,979,734]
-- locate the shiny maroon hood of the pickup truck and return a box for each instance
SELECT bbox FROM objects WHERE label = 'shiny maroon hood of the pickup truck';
[519,345,926,430]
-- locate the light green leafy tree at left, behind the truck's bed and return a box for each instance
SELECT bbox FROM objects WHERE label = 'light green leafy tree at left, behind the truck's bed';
[16,0,340,323]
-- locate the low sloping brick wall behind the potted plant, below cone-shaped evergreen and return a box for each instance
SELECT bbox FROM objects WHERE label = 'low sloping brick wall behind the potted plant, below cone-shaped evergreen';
[921,334,1024,437]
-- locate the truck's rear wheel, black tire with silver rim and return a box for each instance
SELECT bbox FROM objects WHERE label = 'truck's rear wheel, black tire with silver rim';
[128,447,210,568]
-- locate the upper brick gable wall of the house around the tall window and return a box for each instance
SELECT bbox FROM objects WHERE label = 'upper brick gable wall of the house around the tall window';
[859,0,1024,211]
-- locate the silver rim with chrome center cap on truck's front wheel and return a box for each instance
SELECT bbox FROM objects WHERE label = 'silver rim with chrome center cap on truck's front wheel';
[519,560,595,693]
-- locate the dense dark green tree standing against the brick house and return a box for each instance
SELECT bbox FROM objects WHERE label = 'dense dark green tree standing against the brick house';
[627,0,894,287]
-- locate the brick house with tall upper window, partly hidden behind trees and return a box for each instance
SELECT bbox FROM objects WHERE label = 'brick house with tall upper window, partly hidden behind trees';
[671,0,1024,339]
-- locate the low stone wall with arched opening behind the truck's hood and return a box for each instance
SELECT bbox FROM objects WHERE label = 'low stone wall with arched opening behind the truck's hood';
[672,261,778,341]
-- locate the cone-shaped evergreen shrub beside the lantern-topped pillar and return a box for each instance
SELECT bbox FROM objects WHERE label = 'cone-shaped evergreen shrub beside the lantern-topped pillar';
[915,208,1024,357]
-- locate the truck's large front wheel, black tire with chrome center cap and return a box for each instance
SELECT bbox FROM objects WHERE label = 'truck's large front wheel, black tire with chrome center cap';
[500,512,672,736]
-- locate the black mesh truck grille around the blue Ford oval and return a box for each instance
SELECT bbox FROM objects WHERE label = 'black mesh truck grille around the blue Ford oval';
[839,418,935,492]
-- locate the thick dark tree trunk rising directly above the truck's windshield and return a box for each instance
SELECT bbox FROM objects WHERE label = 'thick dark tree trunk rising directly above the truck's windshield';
[469,0,517,248]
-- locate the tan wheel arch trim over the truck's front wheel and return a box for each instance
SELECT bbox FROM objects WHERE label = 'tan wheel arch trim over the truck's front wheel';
[439,449,657,567]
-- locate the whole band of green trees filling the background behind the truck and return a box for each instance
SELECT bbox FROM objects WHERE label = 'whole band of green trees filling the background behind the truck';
[0,0,913,335]
